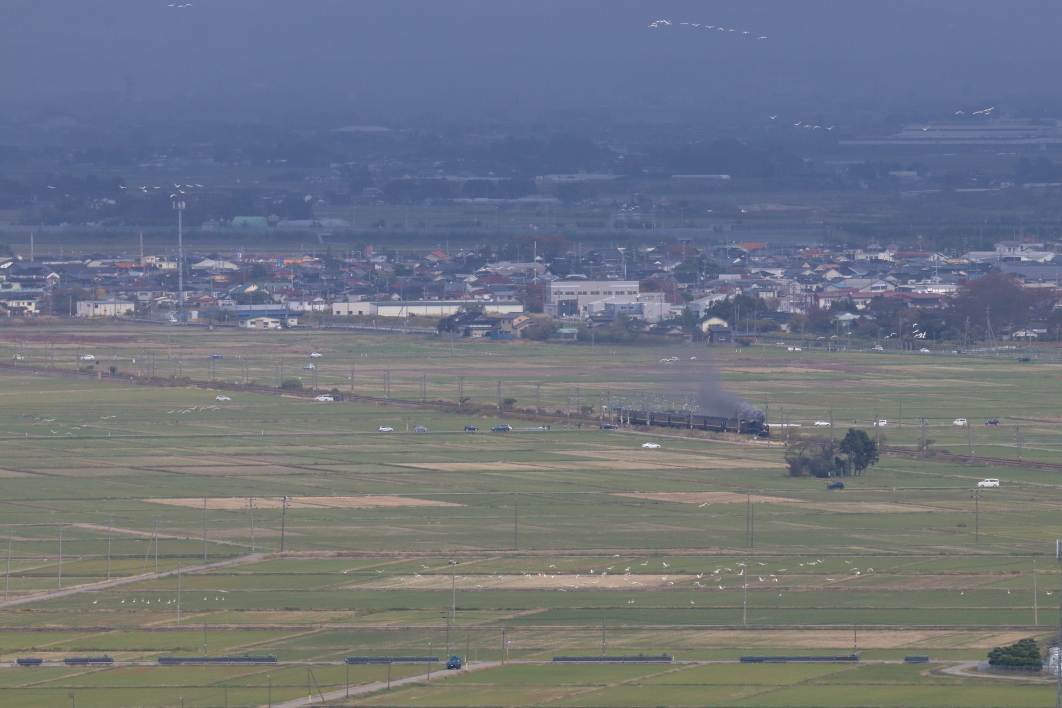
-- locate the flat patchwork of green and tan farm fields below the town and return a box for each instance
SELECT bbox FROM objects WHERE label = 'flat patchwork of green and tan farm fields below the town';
[0,325,1062,707]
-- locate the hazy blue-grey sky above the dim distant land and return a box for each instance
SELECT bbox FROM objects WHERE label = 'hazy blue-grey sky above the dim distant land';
[6,0,1062,122]
